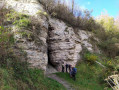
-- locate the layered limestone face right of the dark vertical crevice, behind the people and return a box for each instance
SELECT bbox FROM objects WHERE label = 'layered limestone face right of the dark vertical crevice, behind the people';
[48,19,96,67]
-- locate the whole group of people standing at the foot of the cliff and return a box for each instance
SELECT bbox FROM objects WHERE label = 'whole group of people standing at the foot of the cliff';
[62,63,77,80]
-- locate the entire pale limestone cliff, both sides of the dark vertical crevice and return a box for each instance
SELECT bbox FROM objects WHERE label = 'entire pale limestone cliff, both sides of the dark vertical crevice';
[2,0,99,70]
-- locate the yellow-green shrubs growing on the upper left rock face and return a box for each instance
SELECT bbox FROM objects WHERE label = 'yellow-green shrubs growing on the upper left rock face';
[6,10,34,40]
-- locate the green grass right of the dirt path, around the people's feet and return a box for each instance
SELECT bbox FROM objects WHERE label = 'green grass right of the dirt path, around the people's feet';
[56,62,112,90]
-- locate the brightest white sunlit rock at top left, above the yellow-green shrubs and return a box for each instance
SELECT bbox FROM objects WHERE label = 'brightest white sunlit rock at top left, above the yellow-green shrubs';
[6,0,44,15]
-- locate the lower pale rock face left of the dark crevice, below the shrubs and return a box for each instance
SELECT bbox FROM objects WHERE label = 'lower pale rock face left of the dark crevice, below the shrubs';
[13,24,48,70]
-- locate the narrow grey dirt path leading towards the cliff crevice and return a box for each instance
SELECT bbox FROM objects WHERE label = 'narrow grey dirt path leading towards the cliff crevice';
[47,74,75,90]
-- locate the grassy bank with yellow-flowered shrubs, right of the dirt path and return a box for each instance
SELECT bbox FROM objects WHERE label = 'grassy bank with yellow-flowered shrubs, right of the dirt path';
[56,52,119,90]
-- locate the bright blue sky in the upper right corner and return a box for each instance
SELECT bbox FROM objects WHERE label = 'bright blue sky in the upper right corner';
[63,0,119,17]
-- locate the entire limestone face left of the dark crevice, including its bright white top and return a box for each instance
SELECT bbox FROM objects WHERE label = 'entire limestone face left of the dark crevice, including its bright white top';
[6,0,48,70]
